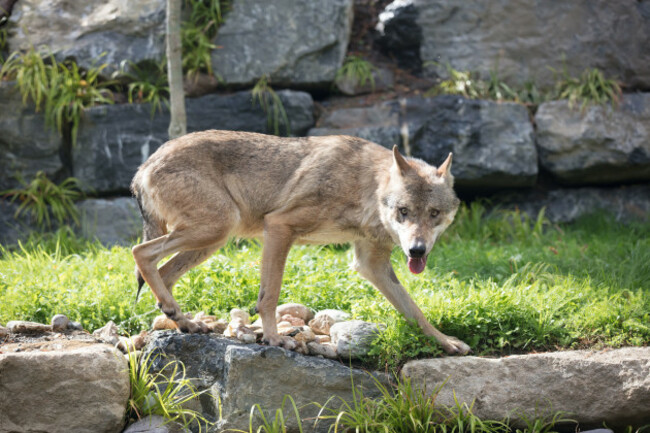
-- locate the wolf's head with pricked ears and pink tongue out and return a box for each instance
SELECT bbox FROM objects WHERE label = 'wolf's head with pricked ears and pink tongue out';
[379,146,460,274]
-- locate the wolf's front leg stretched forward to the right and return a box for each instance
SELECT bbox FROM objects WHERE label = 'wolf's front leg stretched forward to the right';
[354,241,471,355]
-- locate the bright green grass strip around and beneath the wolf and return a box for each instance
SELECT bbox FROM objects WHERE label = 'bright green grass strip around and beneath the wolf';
[0,205,650,368]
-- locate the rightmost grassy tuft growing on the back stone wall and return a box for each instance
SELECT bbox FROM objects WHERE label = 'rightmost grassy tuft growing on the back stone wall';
[551,67,622,110]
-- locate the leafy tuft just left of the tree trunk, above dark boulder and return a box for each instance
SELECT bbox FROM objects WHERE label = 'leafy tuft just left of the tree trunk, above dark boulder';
[121,61,169,117]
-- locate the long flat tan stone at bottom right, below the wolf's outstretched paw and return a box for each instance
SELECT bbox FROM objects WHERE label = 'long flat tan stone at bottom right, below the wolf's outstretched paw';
[402,347,650,431]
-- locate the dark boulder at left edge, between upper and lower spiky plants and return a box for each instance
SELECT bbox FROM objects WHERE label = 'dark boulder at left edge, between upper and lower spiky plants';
[0,82,64,191]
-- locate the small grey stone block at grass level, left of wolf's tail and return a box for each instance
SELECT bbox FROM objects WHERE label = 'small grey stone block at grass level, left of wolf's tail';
[77,197,142,247]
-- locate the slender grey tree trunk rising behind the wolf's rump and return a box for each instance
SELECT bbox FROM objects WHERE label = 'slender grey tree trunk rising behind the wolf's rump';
[167,0,187,140]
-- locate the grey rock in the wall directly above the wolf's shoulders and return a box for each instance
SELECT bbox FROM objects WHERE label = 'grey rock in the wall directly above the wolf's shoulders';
[308,103,400,148]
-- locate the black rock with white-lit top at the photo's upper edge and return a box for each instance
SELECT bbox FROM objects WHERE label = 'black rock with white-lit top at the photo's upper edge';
[376,0,422,74]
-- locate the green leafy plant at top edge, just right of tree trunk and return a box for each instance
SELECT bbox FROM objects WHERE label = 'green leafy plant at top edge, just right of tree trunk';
[181,0,228,79]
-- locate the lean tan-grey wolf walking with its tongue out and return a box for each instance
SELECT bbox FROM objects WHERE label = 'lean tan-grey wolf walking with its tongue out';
[131,130,470,354]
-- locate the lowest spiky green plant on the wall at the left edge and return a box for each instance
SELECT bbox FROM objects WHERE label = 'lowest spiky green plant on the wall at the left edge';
[0,171,83,229]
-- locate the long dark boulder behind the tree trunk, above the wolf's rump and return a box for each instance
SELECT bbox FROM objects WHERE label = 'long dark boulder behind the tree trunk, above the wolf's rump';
[72,90,313,193]
